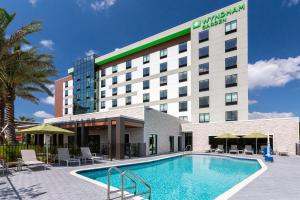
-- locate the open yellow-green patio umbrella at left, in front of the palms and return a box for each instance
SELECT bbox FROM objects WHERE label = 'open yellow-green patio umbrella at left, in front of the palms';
[18,124,75,164]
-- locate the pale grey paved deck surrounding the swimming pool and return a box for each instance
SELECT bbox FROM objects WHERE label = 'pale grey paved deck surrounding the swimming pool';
[0,153,300,200]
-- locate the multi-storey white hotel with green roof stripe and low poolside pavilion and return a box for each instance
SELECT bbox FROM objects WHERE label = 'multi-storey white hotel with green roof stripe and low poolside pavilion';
[46,0,299,158]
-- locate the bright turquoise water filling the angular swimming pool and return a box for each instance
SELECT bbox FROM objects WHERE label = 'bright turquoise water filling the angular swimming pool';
[78,155,261,200]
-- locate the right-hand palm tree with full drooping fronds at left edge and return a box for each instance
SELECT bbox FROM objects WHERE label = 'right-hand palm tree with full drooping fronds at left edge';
[0,9,56,143]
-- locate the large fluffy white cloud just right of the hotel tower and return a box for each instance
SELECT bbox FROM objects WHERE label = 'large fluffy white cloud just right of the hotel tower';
[248,56,300,90]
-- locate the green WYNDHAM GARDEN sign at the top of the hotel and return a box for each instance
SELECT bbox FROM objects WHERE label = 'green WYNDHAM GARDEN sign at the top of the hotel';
[192,3,246,30]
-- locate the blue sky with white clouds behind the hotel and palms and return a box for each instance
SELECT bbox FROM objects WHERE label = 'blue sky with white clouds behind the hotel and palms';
[0,0,300,121]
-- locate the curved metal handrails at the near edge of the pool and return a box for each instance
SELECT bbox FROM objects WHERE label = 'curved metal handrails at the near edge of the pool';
[107,167,151,200]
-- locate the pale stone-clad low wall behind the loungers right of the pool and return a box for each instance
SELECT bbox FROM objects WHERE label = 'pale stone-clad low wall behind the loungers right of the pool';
[182,118,299,155]
